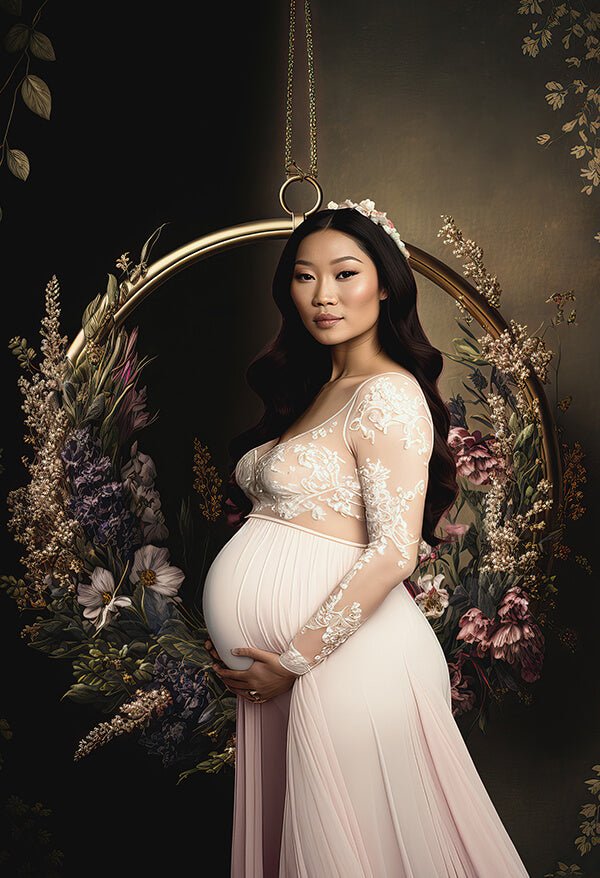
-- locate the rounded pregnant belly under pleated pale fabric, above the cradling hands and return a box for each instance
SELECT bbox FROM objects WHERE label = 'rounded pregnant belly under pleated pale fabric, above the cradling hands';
[202,518,362,670]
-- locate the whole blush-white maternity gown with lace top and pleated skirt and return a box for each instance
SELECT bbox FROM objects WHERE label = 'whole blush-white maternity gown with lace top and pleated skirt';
[203,371,528,878]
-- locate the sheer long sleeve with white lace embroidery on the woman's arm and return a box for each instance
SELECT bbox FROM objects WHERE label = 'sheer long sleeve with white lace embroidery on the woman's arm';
[279,373,434,675]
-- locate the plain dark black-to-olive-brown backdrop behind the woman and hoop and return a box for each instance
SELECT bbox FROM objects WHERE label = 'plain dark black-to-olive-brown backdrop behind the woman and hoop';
[0,0,599,878]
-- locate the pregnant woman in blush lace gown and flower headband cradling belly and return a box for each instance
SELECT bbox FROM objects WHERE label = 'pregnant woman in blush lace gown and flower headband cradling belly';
[203,200,528,878]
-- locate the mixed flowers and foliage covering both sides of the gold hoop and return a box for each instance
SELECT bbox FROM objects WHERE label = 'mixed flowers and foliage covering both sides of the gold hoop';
[0,218,585,782]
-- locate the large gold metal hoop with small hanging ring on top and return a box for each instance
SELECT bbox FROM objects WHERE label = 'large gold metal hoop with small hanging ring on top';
[67,184,563,571]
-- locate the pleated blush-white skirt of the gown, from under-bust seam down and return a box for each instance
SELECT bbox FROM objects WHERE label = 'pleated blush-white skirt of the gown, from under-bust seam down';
[204,515,528,878]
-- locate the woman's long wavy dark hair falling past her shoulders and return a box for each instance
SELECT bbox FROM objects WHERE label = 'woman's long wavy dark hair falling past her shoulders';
[226,208,458,546]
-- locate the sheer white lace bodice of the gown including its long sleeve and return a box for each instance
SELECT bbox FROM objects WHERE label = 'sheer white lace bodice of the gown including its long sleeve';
[235,372,434,674]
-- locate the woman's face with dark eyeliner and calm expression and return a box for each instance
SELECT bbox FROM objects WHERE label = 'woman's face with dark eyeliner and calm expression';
[290,229,387,344]
